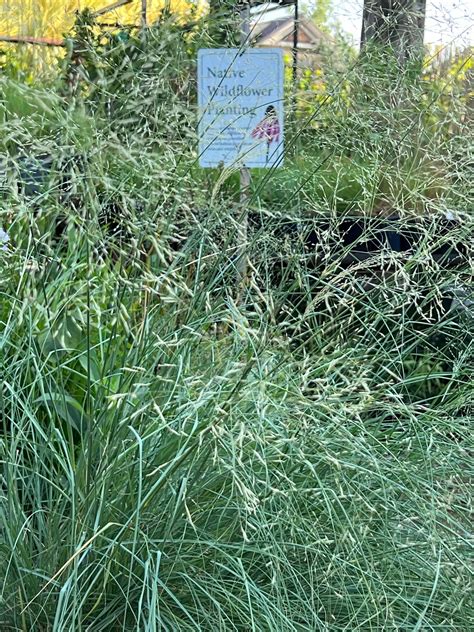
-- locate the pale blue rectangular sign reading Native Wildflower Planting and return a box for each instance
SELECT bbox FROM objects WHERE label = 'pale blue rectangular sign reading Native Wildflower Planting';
[198,48,284,168]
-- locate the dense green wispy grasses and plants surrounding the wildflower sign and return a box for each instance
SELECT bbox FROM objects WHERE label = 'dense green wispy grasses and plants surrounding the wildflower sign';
[0,2,474,632]
